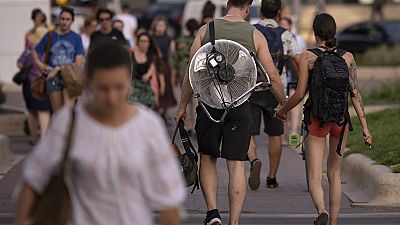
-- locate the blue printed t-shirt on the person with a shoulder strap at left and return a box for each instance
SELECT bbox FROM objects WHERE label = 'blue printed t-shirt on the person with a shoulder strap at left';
[36,31,84,67]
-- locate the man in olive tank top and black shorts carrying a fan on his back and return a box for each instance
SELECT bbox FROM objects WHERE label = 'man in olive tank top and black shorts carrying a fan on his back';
[175,0,285,225]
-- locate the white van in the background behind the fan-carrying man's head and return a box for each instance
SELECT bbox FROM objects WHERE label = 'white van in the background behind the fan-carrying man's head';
[182,0,261,33]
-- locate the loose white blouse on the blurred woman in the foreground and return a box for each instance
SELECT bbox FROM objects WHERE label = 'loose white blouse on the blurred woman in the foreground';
[23,106,186,225]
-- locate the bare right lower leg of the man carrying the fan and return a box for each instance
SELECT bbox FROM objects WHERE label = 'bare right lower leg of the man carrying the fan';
[226,160,247,225]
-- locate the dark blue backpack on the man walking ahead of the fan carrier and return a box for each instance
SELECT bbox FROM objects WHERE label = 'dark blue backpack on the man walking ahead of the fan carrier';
[254,24,287,75]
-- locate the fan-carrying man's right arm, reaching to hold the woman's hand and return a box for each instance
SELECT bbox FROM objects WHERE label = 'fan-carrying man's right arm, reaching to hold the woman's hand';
[253,29,286,105]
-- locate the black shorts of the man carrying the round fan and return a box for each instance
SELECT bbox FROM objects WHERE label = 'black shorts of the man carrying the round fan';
[195,102,251,161]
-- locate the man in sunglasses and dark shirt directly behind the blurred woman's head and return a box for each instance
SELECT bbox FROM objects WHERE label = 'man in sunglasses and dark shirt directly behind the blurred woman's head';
[89,8,128,49]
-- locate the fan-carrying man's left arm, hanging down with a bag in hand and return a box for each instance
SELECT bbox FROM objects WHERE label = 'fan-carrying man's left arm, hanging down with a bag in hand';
[175,25,207,122]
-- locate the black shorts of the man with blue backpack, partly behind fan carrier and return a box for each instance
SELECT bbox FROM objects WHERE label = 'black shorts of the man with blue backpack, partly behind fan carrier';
[250,91,283,137]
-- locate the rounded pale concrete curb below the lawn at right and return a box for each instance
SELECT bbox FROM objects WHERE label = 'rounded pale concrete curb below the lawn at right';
[342,154,400,207]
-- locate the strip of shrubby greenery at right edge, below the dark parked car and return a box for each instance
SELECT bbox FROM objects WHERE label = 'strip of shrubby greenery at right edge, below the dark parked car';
[363,81,400,105]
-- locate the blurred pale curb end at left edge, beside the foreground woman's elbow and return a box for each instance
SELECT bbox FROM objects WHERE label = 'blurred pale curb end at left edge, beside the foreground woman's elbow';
[0,134,24,180]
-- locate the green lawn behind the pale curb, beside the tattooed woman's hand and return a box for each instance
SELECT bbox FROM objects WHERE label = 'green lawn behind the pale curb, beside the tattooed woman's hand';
[346,108,400,173]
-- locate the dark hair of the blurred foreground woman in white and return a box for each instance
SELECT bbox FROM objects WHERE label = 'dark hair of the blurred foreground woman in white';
[86,41,132,80]
